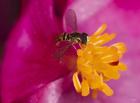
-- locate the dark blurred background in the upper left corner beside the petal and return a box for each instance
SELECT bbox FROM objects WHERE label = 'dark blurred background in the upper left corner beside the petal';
[0,0,21,49]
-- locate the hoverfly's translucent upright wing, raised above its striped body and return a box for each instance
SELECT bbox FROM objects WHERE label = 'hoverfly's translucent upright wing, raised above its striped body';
[64,9,77,32]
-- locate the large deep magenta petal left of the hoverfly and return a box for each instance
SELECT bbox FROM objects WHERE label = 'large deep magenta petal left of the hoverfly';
[2,0,75,103]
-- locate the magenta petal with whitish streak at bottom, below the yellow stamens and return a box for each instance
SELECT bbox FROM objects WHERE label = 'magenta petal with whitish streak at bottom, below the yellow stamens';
[30,79,95,103]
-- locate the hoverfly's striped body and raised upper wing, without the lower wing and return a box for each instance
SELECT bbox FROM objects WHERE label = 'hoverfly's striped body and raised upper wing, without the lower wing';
[56,9,88,44]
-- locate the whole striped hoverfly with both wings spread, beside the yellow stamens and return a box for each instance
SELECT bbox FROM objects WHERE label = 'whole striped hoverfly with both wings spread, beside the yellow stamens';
[56,9,88,58]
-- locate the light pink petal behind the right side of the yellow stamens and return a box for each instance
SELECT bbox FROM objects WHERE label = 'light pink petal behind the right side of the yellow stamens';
[60,0,140,103]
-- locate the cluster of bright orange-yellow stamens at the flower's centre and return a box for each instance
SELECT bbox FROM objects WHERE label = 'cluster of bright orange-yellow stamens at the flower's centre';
[73,24,127,98]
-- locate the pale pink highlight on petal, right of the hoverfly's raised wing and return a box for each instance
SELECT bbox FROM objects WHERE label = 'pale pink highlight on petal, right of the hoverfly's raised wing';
[69,0,112,22]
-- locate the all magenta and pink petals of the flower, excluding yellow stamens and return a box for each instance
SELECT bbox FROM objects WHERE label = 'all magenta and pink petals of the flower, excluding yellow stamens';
[2,0,140,103]
